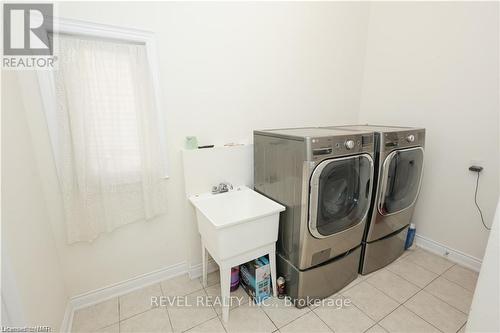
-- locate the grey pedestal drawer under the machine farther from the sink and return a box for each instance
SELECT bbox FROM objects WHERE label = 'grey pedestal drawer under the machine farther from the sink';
[360,225,408,275]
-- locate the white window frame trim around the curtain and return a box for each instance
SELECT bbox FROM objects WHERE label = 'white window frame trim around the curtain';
[37,17,169,179]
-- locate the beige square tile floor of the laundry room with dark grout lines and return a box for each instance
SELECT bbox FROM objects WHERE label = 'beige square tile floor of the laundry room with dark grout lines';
[72,248,477,333]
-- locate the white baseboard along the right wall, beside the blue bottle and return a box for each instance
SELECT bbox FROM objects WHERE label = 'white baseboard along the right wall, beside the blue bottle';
[415,234,482,272]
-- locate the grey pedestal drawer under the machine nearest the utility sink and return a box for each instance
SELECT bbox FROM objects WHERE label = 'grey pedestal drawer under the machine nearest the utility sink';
[276,246,361,308]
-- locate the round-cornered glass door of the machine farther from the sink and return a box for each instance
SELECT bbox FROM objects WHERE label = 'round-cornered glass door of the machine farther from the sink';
[378,147,424,215]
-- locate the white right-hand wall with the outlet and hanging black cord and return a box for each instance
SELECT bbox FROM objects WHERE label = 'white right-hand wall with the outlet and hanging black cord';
[359,2,500,259]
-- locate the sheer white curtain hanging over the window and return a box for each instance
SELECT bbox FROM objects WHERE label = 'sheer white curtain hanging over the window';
[53,35,166,243]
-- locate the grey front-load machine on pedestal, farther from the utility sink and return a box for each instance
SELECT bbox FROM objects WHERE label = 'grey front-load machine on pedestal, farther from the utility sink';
[329,125,425,274]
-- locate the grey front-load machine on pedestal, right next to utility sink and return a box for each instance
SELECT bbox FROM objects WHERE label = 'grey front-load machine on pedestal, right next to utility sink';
[254,128,374,307]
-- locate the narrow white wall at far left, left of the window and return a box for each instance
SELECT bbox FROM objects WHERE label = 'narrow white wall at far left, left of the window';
[2,72,68,330]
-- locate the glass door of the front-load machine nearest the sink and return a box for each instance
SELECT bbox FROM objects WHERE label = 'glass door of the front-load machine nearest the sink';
[309,154,373,238]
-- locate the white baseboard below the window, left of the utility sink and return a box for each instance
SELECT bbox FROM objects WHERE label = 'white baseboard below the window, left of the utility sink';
[60,262,188,332]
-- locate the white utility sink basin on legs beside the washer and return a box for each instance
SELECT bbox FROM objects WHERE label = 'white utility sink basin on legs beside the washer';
[189,186,285,262]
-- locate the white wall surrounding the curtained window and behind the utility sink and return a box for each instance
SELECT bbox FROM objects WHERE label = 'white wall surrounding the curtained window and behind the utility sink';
[7,2,368,296]
